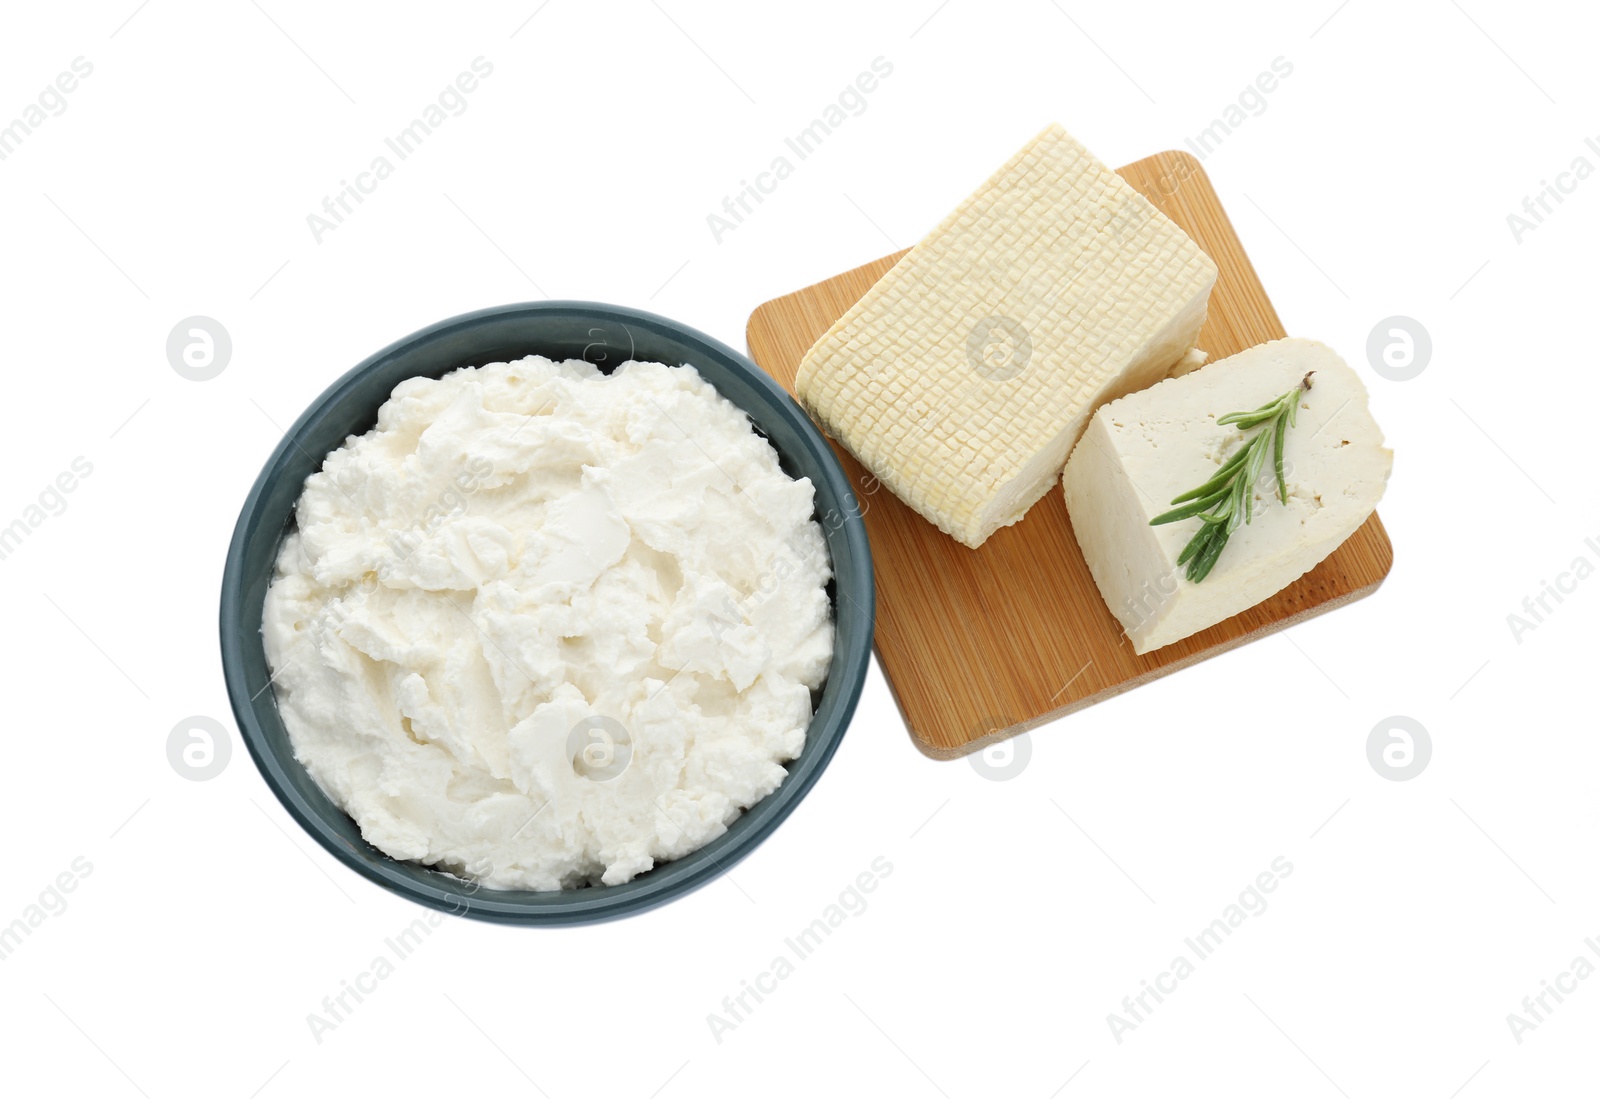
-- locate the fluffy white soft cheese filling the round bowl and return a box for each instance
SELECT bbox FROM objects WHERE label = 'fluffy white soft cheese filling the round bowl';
[262,357,834,889]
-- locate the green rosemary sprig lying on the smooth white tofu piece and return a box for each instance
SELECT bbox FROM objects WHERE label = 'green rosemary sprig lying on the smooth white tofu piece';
[1150,371,1317,584]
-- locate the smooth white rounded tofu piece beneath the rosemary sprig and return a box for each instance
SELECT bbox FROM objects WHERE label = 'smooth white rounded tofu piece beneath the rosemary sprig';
[1062,339,1394,653]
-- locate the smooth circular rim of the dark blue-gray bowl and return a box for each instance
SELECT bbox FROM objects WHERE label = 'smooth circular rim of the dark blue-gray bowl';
[218,299,877,926]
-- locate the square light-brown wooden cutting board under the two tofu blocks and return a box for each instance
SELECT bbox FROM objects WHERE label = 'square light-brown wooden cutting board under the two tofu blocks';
[747,152,1394,760]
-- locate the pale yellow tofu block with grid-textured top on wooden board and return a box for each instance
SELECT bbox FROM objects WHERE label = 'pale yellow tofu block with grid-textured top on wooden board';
[795,126,1216,547]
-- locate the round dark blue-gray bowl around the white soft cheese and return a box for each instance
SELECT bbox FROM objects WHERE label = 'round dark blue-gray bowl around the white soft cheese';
[221,301,874,925]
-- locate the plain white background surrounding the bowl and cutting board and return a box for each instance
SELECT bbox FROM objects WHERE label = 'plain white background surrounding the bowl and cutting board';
[0,0,1600,1099]
